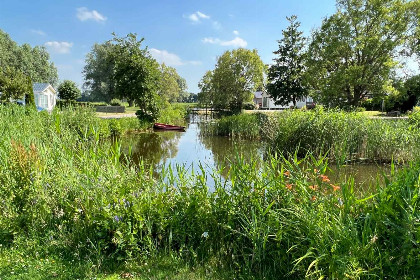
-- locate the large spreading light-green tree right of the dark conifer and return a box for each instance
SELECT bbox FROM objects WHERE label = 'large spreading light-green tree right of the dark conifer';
[306,0,412,107]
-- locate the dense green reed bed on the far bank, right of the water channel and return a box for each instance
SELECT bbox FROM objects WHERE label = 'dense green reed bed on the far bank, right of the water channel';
[204,109,420,162]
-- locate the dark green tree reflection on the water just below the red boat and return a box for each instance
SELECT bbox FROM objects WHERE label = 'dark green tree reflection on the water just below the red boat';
[122,131,181,170]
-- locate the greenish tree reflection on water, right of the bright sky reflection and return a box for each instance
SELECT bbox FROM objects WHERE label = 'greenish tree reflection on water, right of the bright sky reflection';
[201,136,262,173]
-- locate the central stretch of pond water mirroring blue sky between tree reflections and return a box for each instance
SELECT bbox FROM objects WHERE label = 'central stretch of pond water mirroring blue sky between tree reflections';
[122,123,263,185]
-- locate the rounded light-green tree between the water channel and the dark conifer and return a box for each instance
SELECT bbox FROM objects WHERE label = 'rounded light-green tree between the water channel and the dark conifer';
[199,48,265,112]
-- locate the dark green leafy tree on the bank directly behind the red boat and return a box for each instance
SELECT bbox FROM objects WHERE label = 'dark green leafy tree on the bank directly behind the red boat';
[111,33,161,121]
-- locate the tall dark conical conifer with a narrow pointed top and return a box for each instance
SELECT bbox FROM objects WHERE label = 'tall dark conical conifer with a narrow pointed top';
[267,16,308,107]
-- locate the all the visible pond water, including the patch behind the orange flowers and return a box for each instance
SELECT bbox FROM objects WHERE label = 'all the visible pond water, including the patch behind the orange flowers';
[121,115,391,189]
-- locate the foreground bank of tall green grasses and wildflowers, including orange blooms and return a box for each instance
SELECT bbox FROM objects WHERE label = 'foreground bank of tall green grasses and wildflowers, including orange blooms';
[0,104,420,279]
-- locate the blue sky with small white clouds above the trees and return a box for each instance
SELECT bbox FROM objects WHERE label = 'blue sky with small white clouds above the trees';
[0,0,416,93]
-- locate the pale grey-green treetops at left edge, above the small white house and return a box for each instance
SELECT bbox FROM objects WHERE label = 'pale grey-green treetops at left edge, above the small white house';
[0,30,58,86]
